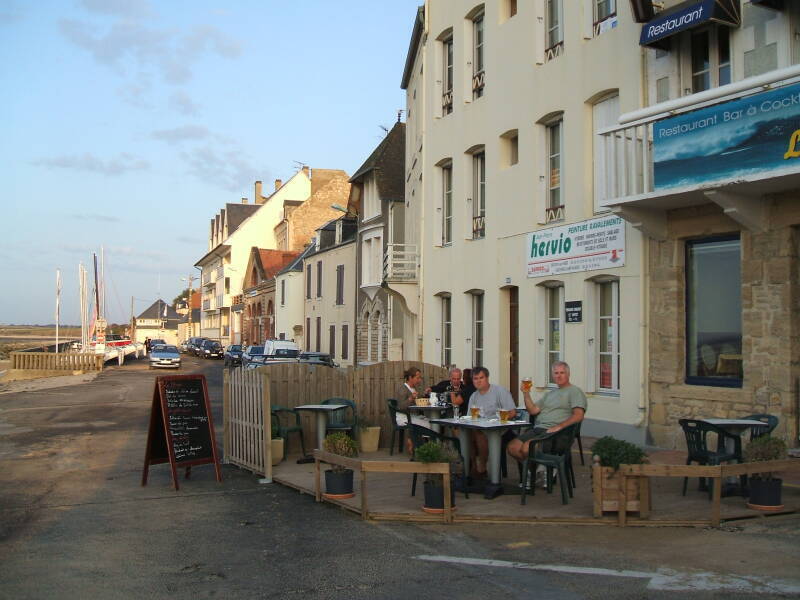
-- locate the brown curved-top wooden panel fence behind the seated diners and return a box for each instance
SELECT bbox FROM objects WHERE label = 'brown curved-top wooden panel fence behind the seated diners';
[225,361,447,460]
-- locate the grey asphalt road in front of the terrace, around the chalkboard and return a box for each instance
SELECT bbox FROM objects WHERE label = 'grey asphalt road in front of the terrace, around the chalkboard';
[0,359,800,599]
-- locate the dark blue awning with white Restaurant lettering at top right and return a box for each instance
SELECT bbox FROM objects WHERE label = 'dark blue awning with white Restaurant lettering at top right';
[639,0,741,48]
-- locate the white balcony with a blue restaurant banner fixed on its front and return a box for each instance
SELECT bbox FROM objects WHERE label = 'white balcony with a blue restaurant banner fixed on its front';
[595,66,800,239]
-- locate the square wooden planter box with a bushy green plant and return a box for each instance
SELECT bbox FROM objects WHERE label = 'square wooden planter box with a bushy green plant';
[592,436,650,517]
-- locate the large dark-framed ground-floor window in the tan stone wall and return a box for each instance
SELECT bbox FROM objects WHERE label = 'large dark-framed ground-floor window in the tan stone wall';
[686,235,742,387]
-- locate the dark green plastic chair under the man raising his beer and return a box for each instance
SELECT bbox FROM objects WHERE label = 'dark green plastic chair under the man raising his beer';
[520,423,578,504]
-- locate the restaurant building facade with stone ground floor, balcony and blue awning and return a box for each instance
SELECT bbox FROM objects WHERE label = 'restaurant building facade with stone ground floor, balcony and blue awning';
[601,0,800,447]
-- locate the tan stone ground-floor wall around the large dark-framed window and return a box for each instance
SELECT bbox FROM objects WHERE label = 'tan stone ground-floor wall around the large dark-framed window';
[648,198,800,448]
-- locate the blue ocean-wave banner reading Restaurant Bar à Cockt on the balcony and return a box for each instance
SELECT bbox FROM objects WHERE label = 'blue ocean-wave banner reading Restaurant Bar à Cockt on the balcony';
[653,83,800,190]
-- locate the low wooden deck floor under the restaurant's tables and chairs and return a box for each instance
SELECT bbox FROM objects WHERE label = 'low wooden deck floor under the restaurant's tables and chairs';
[273,449,800,526]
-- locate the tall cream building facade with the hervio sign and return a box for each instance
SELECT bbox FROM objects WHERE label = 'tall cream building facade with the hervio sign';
[402,0,647,442]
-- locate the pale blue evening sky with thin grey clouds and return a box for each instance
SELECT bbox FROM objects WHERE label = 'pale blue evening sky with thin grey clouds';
[0,0,421,324]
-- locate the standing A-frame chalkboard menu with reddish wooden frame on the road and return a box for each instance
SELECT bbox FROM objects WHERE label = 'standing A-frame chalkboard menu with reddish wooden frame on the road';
[142,375,222,490]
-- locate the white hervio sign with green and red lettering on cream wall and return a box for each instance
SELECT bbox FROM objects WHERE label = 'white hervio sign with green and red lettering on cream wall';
[526,216,625,277]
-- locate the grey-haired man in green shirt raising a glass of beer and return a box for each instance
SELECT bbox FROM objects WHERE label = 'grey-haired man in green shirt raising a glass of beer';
[506,361,586,482]
